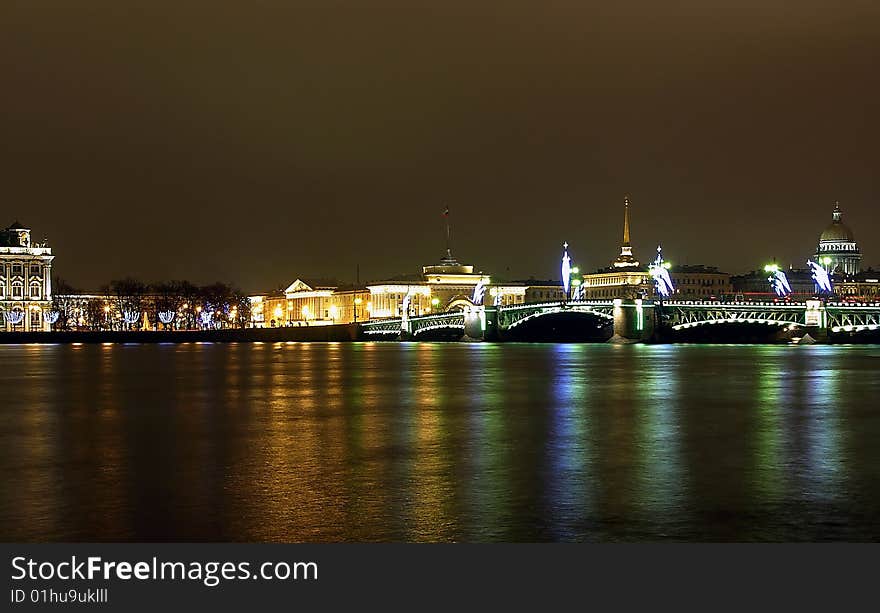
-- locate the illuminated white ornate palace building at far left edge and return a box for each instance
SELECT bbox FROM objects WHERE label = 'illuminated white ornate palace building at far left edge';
[0,222,55,332]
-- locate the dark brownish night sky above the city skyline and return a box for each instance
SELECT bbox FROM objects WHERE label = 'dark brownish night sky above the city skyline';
[0,0,880,291]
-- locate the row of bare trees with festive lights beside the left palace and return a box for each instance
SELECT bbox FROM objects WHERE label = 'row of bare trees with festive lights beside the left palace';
[52,277,251,330]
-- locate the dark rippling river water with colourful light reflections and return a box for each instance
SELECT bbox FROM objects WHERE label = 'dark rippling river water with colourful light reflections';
[0,343,880,541]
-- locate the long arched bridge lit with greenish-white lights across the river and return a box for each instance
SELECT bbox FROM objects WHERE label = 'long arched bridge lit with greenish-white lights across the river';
[359,299,880,342]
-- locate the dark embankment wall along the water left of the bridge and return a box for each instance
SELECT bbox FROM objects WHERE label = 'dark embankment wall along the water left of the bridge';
[0,324,358,345]
